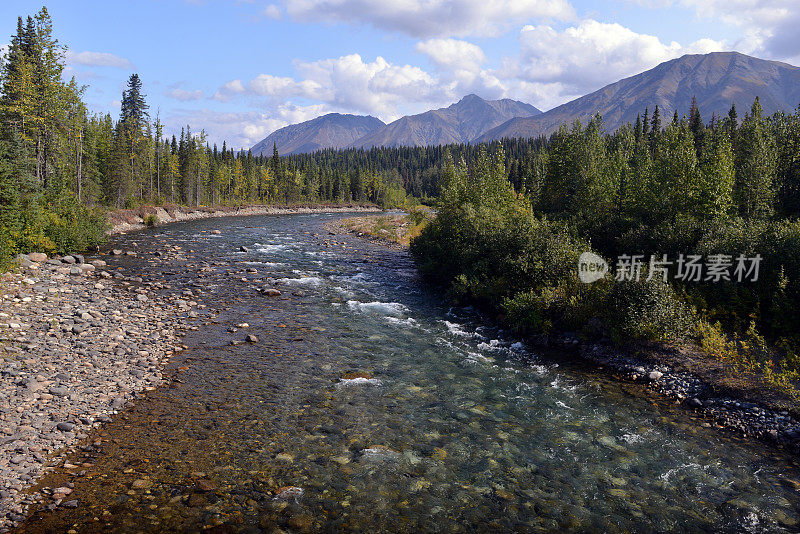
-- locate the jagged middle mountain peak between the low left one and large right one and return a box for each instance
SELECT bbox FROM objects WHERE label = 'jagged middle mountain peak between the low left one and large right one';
[350,95,541,148]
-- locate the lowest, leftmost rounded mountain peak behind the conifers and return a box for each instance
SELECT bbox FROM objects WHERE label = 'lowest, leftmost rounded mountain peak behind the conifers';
[251,113,384,156]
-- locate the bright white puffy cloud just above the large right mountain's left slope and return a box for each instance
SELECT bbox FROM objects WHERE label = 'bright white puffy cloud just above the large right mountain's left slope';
[510,20,724,94]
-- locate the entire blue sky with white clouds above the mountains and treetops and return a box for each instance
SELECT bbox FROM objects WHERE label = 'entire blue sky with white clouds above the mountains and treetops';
[0,0,800,147]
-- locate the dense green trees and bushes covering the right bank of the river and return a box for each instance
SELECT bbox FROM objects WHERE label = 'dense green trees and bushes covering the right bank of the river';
[411,98,800,396]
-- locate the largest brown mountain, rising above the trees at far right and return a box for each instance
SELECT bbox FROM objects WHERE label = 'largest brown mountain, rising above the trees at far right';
[478,52,800,142]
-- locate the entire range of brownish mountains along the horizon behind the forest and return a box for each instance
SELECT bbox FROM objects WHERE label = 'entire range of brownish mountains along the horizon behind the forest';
[252,52,800,154]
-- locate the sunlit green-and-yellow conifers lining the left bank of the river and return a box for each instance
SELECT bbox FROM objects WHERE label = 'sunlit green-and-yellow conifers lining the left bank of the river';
[0,7,406,261]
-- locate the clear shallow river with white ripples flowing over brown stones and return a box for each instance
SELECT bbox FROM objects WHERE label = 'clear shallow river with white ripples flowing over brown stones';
[15,215,800,532]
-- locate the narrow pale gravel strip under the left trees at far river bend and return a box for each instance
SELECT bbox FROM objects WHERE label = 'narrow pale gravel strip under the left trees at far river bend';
[108,203,382,235]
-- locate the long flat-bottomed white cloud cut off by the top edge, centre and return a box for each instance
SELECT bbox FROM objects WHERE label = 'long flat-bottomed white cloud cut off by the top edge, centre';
[284,0,575,37]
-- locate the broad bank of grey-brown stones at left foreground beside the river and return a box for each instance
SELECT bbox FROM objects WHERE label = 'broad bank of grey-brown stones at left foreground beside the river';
[0,252,191,532]
